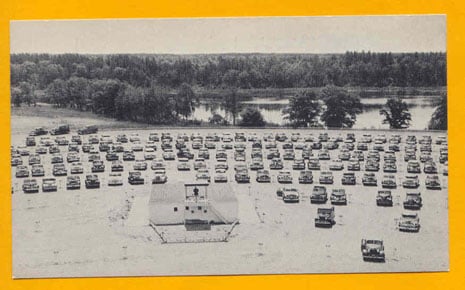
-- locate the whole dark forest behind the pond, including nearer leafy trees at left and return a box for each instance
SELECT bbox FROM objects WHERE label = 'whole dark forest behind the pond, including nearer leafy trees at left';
[11,52,446,123]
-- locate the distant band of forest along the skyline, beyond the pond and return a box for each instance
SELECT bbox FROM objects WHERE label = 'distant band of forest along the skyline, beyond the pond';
[11,52,446,90]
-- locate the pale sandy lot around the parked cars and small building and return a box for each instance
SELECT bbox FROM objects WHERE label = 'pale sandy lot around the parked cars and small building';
[12,116,449,278]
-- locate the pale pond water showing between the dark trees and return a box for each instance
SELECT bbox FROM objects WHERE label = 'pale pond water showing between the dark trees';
[192,96,438,130]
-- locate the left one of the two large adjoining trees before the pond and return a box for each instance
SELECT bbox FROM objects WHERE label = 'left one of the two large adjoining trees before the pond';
[283,90,321,127]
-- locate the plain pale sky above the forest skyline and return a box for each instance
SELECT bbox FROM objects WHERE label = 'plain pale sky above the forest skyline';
[10,15,446,54]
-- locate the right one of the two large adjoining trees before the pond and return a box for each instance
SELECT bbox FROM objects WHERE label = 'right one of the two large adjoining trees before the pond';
[321,87,363,128]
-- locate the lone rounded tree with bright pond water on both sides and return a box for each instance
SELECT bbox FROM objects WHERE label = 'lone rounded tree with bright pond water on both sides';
[379,97,412,129]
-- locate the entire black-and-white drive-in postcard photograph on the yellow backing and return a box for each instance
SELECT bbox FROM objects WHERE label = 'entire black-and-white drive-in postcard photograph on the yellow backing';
[10,15,449,279]
